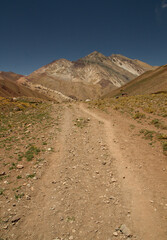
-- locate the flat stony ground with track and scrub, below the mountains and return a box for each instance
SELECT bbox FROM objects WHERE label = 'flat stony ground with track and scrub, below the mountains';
[0,94,167,240]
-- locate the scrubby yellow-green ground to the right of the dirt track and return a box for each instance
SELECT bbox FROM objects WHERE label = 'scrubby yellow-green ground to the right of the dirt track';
[89,93,167,155]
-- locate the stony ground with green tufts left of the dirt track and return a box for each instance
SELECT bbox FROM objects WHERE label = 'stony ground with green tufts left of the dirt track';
[0,97,61,200]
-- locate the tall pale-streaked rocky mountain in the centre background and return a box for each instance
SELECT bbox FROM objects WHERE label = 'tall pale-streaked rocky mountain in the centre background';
[19,51,153,100]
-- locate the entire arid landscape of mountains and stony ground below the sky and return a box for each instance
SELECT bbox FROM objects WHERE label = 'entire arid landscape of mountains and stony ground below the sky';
[0,51,167,240]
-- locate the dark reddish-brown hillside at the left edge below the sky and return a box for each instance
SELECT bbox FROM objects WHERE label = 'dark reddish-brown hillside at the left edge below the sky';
[0,72,49,100]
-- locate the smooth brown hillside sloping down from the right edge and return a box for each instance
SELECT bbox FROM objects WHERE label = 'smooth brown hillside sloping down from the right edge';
[104,65,167,97]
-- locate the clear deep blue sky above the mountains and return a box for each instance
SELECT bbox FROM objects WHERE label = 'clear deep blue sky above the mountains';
[0,0,167,74]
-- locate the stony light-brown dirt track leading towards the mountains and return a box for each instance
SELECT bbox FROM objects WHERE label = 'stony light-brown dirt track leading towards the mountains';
[3,105,167,240]
